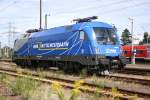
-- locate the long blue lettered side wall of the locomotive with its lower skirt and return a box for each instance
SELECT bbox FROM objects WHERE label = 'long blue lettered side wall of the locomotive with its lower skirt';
[15,27,97,65]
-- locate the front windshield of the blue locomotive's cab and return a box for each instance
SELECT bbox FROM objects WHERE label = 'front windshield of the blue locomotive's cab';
[93,27,118,44]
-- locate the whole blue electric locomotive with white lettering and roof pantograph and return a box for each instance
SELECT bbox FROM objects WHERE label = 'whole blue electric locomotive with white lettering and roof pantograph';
[13,16,125,71]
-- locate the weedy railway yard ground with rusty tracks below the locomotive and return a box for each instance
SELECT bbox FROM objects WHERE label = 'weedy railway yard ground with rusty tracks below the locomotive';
[0,61,150,100]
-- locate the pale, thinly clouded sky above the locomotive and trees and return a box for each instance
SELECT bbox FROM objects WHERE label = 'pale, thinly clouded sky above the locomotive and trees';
[0,0,150,46]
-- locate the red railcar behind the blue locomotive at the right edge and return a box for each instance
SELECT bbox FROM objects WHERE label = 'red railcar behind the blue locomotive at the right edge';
[122,45,150,60]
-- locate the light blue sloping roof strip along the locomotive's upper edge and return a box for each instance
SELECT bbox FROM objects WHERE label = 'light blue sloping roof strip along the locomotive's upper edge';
[31,22,112,37]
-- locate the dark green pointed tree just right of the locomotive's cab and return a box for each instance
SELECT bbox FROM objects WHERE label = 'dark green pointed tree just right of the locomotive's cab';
[121,28,131,45]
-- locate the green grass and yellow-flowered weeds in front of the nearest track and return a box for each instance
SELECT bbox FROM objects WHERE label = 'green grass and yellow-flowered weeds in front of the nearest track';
[0,71,127,100]
